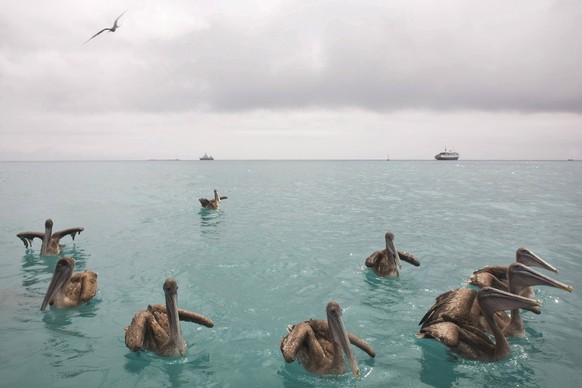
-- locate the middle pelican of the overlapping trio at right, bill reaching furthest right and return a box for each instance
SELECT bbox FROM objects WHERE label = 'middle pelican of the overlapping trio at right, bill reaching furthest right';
[419,262,573,337]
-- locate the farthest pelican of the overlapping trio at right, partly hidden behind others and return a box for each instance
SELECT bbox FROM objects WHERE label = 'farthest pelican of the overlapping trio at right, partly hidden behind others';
[468,247,559,298]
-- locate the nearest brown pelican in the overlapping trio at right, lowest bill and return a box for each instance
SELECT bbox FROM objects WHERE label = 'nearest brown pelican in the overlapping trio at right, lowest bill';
[416,287,541,361]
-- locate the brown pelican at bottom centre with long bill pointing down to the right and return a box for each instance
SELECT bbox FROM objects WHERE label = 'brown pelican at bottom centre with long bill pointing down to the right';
[281,301,376,378]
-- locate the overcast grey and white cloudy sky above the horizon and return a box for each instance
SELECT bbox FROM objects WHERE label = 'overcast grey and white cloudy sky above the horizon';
[0,0,582,160]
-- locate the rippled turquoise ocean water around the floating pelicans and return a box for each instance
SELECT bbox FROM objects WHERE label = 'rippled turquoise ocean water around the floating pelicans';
[0,161,582,387]
